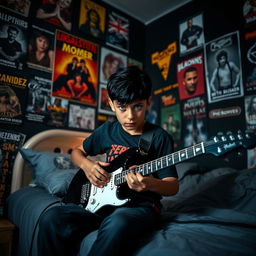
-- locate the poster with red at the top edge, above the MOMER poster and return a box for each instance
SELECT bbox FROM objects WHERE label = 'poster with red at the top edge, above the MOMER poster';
[34,0,72,31]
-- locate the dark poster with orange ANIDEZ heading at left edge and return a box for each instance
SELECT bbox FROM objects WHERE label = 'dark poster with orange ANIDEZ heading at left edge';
[0,72,28,125]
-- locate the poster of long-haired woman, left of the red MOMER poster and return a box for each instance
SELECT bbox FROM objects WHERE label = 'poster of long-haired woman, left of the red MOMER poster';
[27,25,54,72]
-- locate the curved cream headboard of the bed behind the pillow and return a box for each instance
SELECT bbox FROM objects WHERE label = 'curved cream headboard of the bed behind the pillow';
[11,129,90,193]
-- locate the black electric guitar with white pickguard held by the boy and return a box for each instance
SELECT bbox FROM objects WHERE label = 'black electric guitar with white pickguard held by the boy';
[63,131,256,213]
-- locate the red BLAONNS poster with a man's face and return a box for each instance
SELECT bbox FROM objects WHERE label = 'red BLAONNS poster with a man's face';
[177,54,205,100]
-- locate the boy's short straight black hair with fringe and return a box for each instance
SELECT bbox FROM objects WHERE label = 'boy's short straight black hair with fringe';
[107,66,152,104]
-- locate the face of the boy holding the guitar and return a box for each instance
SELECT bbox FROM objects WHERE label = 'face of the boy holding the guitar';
[109,98,151,135]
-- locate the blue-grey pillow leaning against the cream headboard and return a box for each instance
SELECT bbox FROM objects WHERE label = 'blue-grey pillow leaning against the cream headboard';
[19,148,79,196]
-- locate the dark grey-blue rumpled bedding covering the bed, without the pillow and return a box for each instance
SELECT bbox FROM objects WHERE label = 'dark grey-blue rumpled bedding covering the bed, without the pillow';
[8,163,256,256]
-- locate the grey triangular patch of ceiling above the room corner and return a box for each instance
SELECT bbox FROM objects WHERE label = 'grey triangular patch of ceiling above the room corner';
[103,0,192,25]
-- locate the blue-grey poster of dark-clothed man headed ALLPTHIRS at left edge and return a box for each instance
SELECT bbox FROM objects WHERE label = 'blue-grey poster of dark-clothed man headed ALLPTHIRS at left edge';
[0,10,28,70]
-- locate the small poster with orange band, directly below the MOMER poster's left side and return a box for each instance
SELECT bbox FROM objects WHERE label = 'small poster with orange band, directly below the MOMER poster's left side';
[47,97,68,127]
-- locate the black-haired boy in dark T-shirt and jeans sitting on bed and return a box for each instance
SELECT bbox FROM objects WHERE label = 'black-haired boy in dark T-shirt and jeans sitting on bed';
[38,66,179,256]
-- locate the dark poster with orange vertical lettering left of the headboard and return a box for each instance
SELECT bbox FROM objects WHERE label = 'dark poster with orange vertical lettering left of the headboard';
[0,129,25,216]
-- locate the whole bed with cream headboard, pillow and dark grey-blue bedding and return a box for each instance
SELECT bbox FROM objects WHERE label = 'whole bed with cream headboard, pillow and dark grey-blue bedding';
[7,129,256,256]
